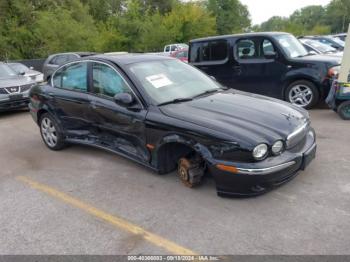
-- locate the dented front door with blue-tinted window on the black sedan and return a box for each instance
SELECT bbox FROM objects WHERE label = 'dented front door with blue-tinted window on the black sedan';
[89,62,150,162]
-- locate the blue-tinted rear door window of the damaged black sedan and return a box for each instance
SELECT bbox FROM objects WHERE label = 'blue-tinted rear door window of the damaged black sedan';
[52,62,88,92]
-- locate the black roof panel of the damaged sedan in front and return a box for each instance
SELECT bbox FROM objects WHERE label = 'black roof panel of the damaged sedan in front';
[86,54,174,66]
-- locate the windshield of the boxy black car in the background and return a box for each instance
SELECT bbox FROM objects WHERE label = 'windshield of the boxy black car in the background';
[275,35,309,58]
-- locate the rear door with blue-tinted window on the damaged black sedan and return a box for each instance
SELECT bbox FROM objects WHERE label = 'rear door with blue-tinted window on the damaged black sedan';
[52,61,90,133]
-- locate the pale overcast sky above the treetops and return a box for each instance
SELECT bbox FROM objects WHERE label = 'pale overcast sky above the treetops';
[240,0,331,24]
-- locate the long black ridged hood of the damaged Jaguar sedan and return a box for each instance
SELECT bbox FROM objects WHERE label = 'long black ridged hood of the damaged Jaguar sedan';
[160,90,309,147]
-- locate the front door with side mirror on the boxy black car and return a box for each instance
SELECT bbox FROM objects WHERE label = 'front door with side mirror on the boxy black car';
[233,37,288,98]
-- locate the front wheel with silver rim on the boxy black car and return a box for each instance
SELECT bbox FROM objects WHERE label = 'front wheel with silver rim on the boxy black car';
[286,80,320,109]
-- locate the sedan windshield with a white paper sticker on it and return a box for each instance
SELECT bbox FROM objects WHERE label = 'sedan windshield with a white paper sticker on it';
[129,60,221,105]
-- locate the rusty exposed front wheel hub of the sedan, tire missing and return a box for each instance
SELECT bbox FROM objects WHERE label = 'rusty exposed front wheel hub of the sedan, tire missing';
[177,157,204,188]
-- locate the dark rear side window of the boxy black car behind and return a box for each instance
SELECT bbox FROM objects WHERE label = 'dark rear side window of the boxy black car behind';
[190,40,228,62]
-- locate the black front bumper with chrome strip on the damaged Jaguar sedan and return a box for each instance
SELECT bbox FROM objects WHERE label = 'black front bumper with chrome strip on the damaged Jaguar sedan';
[209,131,317,196]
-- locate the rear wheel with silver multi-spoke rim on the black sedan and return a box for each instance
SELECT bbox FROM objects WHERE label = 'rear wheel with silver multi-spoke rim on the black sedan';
[39,113,66,151]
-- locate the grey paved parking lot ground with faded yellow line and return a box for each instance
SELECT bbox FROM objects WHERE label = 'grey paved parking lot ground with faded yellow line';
[0,110,350,254]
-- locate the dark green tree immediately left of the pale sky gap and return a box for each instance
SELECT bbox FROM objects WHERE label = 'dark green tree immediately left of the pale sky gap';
[207,0,251,35]
